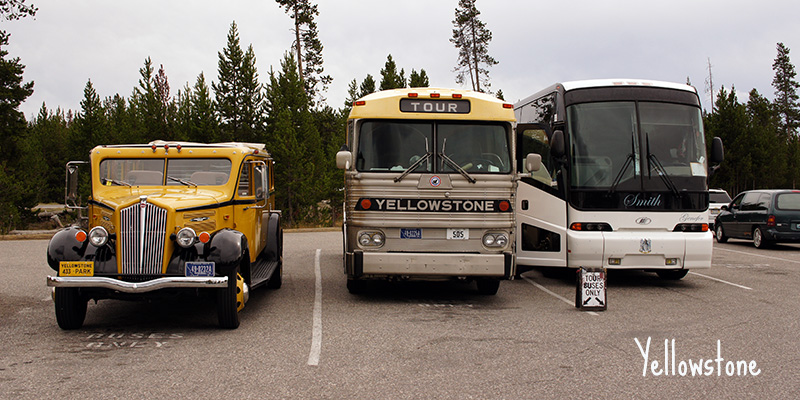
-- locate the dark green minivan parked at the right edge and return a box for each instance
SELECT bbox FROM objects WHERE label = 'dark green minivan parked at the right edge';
[715,189,800,248]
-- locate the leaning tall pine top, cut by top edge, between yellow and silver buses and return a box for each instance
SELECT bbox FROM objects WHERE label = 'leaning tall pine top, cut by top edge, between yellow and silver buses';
[276,0,333,102]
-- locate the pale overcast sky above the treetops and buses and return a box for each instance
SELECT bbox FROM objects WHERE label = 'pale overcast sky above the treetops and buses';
[0,0,800,119]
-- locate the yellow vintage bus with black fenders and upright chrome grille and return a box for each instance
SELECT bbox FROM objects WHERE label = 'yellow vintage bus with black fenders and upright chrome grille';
[47,141,283,329]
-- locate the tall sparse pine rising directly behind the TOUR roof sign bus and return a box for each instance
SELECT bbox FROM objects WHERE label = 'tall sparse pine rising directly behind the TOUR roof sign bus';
[450,0,497,92]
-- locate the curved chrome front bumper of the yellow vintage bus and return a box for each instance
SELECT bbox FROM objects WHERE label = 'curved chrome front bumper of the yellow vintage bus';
[47,276,228,293]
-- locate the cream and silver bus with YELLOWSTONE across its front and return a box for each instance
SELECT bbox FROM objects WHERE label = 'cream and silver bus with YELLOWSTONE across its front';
[336,88,541,295]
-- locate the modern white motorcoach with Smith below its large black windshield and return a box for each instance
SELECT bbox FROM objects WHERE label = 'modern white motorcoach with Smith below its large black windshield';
[514,79,723,279]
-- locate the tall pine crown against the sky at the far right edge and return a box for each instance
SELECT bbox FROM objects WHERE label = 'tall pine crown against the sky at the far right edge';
[772,43,800,140]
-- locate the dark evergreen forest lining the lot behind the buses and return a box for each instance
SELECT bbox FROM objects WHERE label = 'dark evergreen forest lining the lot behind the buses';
[0,0,800,233]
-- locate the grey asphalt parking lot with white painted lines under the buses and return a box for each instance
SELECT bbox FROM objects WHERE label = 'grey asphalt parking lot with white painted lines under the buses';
[0,232,800,399]
